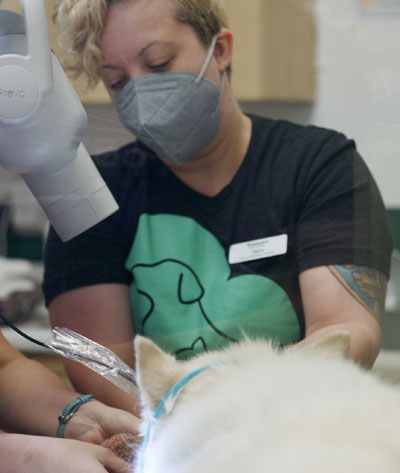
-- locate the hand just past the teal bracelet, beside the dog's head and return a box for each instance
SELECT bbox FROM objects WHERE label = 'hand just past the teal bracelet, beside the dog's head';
[65,401,139,445]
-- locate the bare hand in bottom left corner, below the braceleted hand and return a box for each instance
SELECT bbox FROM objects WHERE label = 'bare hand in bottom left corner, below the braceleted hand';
[0,434,132,473]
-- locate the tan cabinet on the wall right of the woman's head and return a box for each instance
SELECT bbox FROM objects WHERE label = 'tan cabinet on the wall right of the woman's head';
[222,0,315,102]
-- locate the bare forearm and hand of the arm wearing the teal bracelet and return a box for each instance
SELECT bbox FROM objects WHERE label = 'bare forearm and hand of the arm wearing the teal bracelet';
[0,331,138,443]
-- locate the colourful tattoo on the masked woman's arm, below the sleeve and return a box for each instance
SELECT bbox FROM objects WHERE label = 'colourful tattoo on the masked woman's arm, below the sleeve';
[328,264,386,321]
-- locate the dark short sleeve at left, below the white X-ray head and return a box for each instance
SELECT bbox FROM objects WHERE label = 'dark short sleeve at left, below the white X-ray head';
[42,149,135,305]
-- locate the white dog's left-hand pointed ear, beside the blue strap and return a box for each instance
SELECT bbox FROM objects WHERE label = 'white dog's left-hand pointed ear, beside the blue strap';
[134,335,186,412]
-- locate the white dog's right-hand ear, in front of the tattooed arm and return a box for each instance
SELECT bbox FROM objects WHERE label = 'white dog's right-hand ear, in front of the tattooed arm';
[291,329,350,358]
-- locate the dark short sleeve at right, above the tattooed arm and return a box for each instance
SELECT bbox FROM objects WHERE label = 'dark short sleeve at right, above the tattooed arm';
[296,129,393,276]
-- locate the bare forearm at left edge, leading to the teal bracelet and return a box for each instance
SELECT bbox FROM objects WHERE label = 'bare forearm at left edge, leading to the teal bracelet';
[0,357,77,436]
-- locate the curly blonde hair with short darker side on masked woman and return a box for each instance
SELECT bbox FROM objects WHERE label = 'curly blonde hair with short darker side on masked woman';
[53,0,227,88]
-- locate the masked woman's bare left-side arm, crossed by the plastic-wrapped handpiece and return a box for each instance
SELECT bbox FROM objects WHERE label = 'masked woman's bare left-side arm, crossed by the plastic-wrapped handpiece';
[49,284,138,414]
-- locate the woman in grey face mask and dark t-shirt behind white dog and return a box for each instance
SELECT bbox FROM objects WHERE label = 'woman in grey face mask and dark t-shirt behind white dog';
[43,0,392,409]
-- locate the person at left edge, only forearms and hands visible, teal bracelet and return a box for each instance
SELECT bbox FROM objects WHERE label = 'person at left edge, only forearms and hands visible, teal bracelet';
[0,332,136,473]
